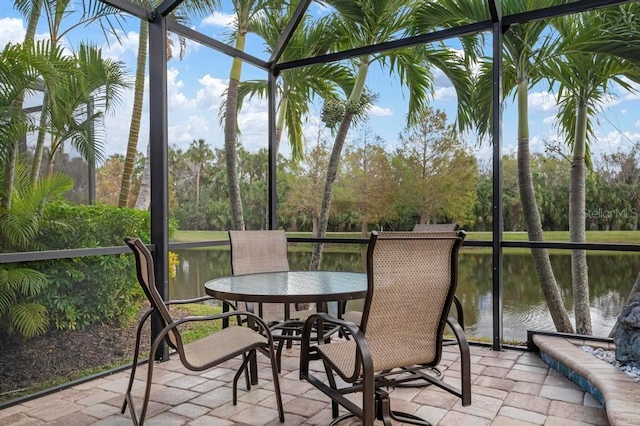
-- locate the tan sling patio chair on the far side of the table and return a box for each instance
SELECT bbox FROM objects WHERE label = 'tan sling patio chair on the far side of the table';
[229,229,316,371]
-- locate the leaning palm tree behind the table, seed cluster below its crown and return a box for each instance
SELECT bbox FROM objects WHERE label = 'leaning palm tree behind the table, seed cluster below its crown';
[310,0,466,269]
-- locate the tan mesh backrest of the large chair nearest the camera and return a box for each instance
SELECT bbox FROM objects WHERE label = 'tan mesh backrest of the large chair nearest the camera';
[361,231,465,371]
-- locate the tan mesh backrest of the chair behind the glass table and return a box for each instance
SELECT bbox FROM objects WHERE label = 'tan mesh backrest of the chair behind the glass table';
[229,229,289,275]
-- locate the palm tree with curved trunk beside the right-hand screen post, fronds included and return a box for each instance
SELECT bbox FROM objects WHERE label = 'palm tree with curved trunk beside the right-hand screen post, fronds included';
[415,0,573,333]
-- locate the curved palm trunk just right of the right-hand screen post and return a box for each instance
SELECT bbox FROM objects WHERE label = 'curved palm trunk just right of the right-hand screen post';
[517,78,573,333]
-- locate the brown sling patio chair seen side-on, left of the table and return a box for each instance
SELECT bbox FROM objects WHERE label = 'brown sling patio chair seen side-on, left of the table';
[121,237,284,425]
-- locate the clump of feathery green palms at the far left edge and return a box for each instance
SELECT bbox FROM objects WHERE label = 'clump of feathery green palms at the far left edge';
[0,0,129,337]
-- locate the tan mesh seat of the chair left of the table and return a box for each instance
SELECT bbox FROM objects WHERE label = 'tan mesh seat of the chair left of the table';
[184,325,268,368]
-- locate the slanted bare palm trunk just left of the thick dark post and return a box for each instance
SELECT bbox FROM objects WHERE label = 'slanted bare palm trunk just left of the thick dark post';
[118,20,149,207]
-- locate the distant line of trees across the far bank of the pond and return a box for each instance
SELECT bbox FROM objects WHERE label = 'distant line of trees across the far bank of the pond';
[92,110,640,233]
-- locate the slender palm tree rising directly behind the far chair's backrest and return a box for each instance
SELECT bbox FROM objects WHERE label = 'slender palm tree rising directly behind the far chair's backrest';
[223,0,277,230]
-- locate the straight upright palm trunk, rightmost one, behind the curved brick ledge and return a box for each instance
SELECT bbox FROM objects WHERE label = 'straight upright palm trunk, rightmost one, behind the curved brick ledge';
[569,98,593,335]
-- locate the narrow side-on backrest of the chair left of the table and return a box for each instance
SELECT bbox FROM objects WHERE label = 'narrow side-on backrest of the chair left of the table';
[124,237,181,349]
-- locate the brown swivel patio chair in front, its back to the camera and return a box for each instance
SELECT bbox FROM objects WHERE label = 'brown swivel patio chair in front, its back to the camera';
[300,231,471,426]
